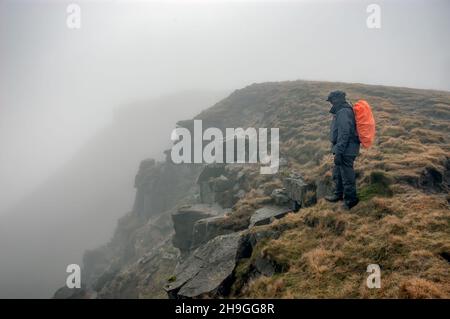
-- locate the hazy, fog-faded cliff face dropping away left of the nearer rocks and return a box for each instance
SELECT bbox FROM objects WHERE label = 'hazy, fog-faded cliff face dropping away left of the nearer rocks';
[51,159,204,298]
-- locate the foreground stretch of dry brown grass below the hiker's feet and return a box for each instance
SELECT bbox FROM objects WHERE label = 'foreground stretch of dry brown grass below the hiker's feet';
[236,190,450,298]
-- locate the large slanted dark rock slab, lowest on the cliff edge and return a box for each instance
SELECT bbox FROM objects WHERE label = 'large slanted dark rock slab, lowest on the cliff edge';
[166,233,246,298]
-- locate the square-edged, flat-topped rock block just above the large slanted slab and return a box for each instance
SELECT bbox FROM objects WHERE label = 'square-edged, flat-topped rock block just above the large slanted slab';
[172,204,223,253]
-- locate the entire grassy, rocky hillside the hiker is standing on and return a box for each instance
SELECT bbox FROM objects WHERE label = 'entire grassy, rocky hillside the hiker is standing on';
[55,81,450,298]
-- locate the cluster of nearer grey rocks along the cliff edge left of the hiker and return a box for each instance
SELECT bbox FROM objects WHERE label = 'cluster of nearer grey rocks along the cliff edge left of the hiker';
[166,164,306,298]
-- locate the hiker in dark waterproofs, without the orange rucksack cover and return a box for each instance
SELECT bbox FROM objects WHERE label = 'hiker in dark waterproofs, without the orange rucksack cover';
[325,91,360,210]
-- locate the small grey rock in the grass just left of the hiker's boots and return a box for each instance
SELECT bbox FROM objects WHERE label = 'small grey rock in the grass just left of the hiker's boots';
[283,174,317,207]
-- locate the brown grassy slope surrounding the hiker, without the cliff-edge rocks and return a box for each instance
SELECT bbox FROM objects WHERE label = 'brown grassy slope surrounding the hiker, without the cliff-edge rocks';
[199,81,450,298]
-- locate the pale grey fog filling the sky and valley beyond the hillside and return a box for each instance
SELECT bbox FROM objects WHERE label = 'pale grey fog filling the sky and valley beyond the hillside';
[0,0,450,297]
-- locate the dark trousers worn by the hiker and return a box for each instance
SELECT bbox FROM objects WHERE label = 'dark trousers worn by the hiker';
[333,155,357,202]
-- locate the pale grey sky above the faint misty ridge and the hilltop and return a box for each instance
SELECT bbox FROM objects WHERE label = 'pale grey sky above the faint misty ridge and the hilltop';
[0,0,450,209]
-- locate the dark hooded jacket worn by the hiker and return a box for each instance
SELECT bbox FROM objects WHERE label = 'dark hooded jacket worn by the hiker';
[330,98,360,156]
